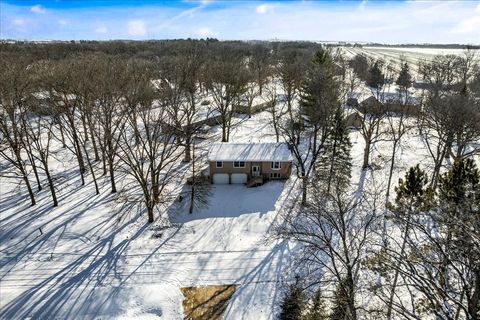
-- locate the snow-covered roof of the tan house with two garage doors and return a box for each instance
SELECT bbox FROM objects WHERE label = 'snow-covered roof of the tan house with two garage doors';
[208,142,292,162]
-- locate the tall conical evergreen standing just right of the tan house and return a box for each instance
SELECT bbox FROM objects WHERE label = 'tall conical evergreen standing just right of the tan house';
[316,108,352,193]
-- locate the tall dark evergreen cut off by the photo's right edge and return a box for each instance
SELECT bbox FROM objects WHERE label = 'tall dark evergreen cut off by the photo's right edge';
[432,158,480,319]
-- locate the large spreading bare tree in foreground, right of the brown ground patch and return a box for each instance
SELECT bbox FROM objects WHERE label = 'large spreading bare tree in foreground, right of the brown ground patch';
[278,187,378,319]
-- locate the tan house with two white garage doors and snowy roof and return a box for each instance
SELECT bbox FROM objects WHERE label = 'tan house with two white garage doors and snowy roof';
[208,142,292,186]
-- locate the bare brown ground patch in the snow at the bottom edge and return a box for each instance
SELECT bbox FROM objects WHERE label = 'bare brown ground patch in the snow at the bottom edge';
[180,284,237,320]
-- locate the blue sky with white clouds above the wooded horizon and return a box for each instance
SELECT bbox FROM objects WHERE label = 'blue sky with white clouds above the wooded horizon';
[0,0,480,44]
